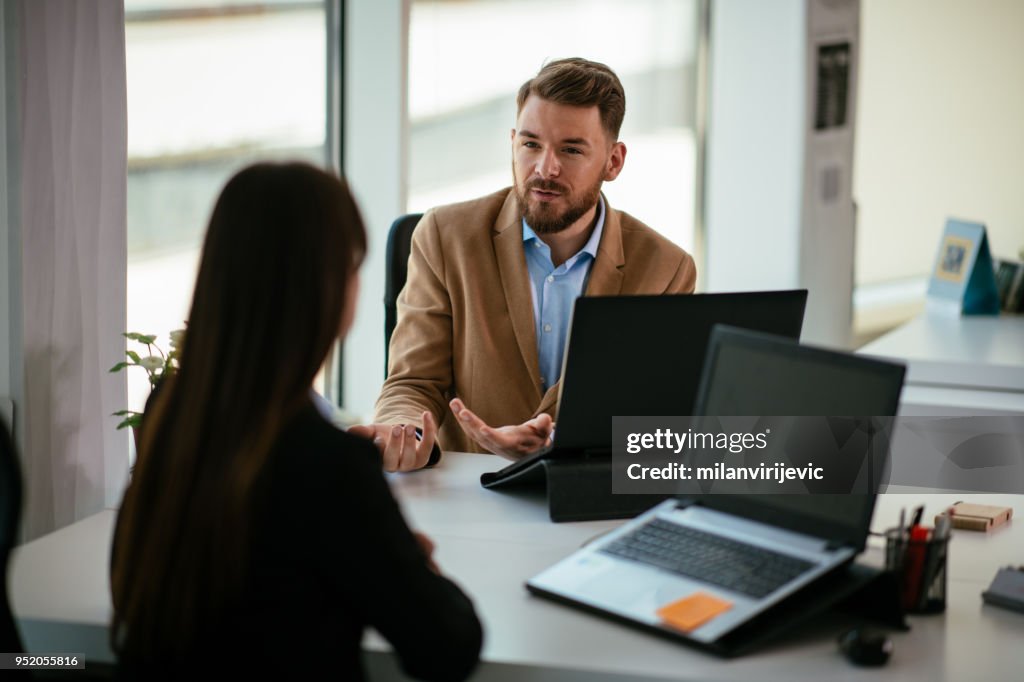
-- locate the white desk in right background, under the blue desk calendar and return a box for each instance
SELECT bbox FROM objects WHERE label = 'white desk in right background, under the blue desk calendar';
[858,313,1024,416]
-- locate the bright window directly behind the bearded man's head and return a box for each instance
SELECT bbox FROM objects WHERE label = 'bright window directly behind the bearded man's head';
[409,0,698,251]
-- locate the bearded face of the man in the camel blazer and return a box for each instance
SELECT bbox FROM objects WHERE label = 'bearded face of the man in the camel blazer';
[512,95,626,235]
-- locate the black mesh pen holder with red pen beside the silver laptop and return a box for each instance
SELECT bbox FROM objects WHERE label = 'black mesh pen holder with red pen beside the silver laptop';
[886,528,949,613]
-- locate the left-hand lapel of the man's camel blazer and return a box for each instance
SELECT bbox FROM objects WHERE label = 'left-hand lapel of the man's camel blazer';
[494,187,542,399]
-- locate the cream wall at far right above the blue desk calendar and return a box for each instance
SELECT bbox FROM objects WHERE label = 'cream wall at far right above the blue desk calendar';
[854,0,1024,284]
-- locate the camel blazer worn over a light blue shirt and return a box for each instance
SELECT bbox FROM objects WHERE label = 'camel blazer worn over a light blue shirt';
[374,188,696,452]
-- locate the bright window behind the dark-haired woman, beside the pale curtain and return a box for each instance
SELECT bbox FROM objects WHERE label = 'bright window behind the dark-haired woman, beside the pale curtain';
[125,0,329,410]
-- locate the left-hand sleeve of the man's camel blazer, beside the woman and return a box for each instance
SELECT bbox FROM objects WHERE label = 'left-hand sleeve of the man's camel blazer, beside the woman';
[374,211,453,436]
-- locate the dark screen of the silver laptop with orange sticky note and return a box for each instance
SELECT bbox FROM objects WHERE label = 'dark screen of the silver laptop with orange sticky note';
[695,327,904,549]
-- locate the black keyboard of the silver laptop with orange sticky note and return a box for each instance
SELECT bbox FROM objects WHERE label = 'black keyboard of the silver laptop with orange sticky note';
[601,518,814,599]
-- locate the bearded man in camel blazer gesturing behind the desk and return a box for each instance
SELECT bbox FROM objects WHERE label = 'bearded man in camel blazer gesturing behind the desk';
[353,58,696,471]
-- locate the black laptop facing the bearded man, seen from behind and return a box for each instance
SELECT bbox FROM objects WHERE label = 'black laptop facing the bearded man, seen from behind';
[480,289,807,489]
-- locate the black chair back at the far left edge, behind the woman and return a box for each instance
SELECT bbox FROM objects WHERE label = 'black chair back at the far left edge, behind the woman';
[0,419,30,679]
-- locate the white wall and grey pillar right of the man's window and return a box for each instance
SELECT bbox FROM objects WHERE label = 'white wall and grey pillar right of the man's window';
[705,0,859,348]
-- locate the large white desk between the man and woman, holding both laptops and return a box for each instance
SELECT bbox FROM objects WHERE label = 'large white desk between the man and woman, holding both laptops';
[10,454,1024,682]
